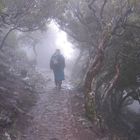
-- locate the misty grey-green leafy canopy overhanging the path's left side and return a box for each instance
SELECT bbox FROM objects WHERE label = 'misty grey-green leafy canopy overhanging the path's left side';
[0,0,64,48]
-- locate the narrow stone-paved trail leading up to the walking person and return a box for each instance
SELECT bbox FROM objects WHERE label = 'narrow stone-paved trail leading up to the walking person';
[22,82,95,140]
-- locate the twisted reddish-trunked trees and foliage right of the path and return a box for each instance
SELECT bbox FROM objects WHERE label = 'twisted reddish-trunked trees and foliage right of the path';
[56,0,140,139]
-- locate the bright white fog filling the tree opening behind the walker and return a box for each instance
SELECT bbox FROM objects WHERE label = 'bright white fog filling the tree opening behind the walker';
[19,21,79,76]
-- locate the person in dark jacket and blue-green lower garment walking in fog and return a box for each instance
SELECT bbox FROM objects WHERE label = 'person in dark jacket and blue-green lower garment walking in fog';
[50,49,65,89]
